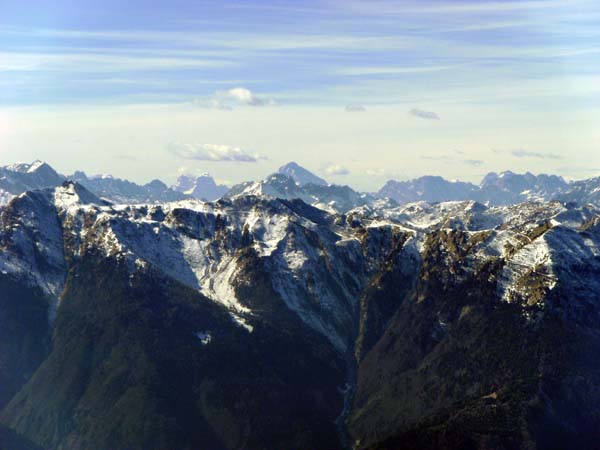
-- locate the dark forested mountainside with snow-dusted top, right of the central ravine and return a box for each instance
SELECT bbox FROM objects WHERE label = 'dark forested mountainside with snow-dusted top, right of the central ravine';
[349,215,600,449]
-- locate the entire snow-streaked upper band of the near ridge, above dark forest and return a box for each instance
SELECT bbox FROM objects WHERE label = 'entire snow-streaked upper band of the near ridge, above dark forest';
[0,181,600,351]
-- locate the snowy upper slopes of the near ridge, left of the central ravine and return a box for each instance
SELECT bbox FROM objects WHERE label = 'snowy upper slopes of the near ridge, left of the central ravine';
[0,183,392,351]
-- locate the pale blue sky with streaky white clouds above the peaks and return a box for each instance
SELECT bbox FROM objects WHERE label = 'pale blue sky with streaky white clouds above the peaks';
[0,0,600,190]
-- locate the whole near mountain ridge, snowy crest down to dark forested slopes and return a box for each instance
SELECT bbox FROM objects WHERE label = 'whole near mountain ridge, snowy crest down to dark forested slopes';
[0,183,600,450]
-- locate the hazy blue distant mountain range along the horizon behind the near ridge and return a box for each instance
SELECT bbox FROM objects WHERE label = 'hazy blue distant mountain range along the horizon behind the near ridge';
[0,161,600,213]
